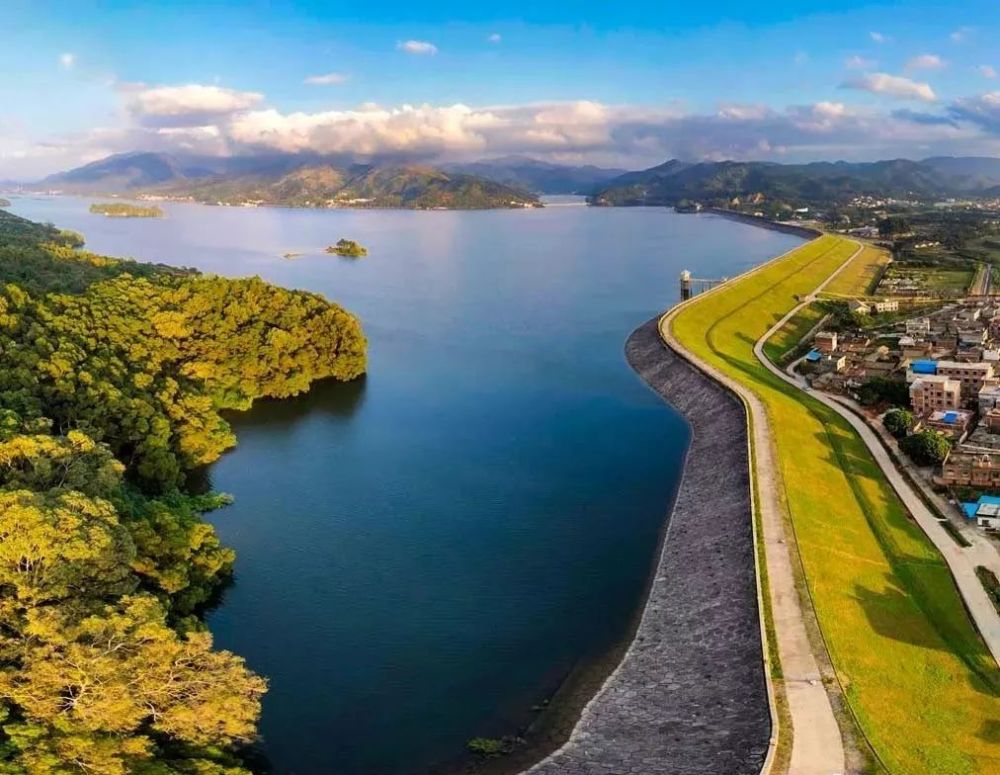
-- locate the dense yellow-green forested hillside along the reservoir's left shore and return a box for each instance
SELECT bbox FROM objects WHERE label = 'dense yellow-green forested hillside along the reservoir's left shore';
[0,213,365,775]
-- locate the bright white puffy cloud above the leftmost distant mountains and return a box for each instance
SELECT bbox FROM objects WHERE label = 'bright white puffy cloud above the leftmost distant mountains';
[122,84,264,126]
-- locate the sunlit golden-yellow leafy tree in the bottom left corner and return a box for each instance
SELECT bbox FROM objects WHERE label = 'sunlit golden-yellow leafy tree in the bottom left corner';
[0,595,266,771]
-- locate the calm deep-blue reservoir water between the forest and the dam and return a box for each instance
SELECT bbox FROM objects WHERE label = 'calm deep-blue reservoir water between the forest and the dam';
[3,198,798,775]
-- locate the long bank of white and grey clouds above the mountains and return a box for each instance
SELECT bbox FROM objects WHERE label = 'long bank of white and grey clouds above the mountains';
[0,79,1000,177]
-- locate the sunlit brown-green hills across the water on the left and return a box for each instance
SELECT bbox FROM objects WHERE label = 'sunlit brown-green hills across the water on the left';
[35,153,538,209]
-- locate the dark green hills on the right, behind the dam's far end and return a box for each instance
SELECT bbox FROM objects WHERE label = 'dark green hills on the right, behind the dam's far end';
[592,159,980,205]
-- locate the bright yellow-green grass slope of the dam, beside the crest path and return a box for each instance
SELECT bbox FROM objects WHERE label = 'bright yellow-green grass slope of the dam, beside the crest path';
[673,236,1000,775]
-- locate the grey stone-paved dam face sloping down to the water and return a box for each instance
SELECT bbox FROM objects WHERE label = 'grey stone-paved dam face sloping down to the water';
[528,319,771,775]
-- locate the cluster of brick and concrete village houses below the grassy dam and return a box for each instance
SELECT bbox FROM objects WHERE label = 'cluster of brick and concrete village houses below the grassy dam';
[800,296,1000,536]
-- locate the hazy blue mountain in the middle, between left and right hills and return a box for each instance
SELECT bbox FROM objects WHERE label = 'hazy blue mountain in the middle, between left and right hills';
[442,156,625,195]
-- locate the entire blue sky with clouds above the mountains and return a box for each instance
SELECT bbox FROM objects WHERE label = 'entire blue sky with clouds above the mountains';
[0,0,1000,180]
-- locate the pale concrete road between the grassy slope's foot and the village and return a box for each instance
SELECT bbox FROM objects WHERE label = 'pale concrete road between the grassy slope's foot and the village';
[753,253,1000,664]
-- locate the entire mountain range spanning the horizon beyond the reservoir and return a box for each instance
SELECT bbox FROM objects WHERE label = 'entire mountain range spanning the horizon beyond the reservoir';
[23,152,1000,209]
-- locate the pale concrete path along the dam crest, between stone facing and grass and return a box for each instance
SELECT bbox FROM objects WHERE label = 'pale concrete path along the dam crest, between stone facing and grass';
[660,242,848,775]
